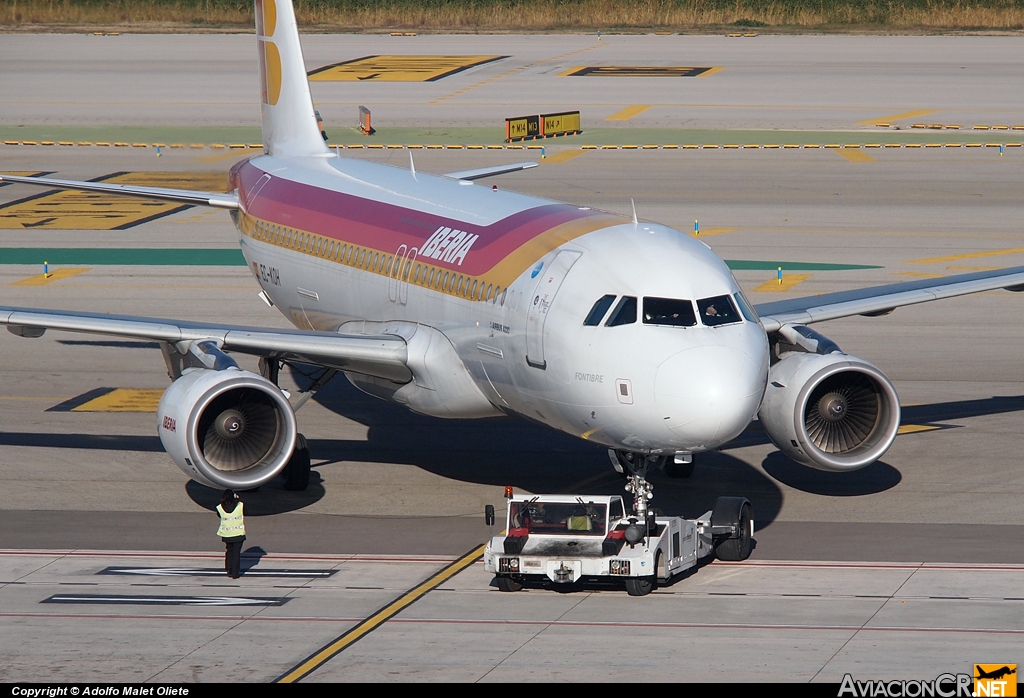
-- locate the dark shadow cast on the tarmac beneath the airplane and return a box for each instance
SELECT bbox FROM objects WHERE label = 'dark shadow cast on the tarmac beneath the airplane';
[14,364,1024,521]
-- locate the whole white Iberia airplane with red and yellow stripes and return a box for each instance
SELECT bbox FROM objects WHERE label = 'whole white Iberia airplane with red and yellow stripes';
[0,0,1024,511]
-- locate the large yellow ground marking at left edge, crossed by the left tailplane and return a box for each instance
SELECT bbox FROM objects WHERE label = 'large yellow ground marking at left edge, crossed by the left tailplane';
[0,172,227,230]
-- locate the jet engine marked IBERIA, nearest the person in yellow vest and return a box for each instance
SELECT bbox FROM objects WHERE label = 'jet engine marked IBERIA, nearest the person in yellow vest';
[157,367,298,489]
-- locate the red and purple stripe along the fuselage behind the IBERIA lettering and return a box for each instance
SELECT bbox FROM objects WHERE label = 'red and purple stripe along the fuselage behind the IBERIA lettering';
[230,161,607,276]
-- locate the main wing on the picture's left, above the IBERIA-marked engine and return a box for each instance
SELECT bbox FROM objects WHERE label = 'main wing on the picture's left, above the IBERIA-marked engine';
[0,306,413,383]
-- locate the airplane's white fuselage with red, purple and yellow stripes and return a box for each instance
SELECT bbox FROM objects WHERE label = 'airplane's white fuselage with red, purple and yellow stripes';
[232,151,769,453]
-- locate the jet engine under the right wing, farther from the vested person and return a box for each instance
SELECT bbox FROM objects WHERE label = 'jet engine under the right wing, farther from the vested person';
[758,352,900,472]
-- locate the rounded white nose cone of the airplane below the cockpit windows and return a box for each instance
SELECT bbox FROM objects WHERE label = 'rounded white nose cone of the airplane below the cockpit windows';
[654,346,765,448]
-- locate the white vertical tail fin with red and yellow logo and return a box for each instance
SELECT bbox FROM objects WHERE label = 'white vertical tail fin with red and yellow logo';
[255,0,330,156]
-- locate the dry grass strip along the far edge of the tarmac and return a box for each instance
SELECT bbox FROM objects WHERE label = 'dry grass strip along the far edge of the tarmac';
[6,0,1024,32]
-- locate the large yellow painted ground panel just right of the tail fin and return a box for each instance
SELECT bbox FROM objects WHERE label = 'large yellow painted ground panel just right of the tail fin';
[309,55,508,82]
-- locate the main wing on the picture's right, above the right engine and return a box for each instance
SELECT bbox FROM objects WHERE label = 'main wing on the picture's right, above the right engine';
[755,266,1024,332]
